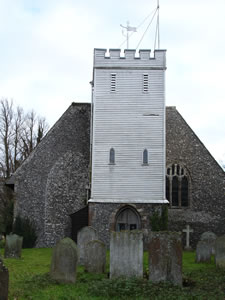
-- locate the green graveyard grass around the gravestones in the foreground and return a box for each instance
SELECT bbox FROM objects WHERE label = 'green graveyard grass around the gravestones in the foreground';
[1,249,225,300]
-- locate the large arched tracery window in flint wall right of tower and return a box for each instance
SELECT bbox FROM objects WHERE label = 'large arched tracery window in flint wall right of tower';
[166,164,190,207]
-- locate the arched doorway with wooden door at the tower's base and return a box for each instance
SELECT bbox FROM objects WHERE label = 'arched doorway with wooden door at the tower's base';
[115,206,141,231]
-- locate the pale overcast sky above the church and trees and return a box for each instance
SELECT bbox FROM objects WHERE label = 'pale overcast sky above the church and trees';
[0,0,225,166]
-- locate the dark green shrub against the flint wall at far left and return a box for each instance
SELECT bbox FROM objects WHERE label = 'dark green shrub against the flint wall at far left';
[13,216,37,248]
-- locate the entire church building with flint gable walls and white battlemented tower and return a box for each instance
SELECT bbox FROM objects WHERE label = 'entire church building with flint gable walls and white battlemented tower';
[11,49,225,247]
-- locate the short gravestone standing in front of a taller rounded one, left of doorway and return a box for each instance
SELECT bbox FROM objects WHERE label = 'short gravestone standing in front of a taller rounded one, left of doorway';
[84,240,106,273]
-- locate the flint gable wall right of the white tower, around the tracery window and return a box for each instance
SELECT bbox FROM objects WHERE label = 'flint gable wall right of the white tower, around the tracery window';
[166,107,225,247]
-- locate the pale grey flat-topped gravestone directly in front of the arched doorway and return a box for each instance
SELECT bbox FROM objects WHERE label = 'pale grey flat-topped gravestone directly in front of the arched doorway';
[110,230,143,278]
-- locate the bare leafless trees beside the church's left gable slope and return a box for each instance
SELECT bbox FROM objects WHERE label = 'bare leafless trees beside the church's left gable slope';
[0,98,48,178]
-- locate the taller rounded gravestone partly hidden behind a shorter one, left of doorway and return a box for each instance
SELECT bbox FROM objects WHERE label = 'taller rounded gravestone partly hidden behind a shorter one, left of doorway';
[77,226,98,265]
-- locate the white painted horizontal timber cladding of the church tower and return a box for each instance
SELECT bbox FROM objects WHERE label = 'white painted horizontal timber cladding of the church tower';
[91,49,166,202]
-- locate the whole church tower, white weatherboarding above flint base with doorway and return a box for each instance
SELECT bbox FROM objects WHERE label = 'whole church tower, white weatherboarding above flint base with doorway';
[88,49,168,243]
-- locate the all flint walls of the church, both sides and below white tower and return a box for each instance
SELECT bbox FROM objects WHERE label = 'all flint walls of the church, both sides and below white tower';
[12,103,225,247]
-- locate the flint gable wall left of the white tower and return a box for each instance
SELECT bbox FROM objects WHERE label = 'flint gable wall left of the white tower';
[15,103,90,247]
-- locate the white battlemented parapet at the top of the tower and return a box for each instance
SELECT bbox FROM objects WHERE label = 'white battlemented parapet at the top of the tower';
[94,48,166,69]
